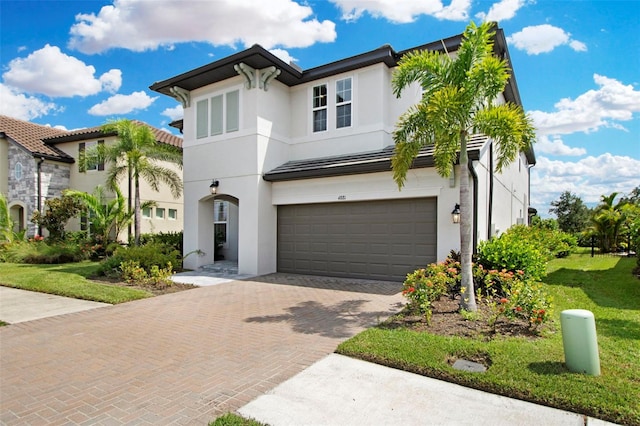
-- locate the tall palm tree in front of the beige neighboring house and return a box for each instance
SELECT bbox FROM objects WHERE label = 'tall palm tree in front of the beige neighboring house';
[98,119,182,245]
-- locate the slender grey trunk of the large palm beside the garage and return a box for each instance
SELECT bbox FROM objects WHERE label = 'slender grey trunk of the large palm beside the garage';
[460,132,478,312]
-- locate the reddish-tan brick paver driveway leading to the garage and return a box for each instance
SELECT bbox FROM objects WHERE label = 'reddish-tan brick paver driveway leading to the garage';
[0,274,403,425]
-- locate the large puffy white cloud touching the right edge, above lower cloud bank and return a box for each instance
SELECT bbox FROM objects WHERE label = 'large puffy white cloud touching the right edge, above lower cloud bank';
[530,74,640,135]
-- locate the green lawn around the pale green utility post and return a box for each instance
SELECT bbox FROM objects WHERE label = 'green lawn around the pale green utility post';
[337,254,640,425]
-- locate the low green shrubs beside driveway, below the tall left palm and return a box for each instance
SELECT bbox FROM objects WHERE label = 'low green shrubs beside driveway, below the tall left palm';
[98,243,182,276]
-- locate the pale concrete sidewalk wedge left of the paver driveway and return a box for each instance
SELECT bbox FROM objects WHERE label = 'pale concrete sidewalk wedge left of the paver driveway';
[0,286,111,324]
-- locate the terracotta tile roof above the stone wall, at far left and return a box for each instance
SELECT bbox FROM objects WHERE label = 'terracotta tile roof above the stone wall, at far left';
[0,115,73,162]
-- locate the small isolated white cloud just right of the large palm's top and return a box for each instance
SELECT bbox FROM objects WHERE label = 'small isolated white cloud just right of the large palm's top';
[507,24,587,55]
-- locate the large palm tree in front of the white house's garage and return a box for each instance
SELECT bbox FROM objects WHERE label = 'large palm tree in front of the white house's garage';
[392,22,535,311]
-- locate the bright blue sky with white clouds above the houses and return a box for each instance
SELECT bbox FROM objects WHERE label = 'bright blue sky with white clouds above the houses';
[0,0,640,217]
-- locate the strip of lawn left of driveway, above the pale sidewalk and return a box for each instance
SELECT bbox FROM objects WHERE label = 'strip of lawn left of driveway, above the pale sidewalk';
[0,262,152,304]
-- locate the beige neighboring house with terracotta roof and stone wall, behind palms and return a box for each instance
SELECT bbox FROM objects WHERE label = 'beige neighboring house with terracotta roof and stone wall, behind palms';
[0,116,184,241]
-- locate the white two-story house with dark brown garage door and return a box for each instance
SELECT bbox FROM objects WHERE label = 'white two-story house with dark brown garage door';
[151,25,535,280]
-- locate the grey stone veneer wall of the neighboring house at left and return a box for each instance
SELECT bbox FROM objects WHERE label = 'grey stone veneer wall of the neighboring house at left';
[8,143,71,237]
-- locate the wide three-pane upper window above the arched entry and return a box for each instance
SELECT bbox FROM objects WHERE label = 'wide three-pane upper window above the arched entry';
[196,90,240,139]
